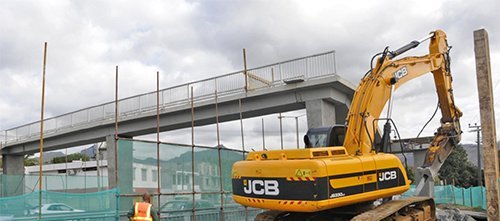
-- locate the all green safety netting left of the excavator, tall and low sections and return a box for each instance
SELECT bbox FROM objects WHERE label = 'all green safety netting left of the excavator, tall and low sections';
[0,139,261,221]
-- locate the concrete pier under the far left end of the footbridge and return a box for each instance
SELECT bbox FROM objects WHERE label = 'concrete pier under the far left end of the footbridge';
[0,154,24,196]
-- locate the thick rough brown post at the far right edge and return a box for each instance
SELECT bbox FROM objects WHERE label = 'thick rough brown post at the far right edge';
[474,29,500,220]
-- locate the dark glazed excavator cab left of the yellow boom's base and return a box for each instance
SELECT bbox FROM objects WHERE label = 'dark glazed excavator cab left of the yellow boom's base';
[304,125,346,148]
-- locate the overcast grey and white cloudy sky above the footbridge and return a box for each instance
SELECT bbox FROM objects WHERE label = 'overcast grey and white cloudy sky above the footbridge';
[0,0,500,152]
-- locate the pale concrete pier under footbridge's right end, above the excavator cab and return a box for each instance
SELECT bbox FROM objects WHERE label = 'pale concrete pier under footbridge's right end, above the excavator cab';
[306,99,337,128]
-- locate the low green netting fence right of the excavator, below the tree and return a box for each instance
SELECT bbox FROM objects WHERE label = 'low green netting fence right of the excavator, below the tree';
[403,185,486,209]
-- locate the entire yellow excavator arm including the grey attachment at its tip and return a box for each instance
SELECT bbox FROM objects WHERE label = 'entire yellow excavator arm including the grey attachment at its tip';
[344,30,462,196]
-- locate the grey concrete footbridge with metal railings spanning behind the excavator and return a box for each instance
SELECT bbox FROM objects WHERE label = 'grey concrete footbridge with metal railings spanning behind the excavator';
[0,51,354,157]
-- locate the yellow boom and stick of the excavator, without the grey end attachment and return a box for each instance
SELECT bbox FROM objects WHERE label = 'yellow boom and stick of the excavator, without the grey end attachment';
[344,30,462,154]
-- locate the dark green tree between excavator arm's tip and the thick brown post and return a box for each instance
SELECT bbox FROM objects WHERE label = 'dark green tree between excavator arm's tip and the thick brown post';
[439,145,477,187]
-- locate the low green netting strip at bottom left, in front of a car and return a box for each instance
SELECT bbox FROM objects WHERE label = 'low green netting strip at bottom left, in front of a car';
[0,189,119,220]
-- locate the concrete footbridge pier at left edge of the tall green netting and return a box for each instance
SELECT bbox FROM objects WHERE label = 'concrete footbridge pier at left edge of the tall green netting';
[106,135,134,211]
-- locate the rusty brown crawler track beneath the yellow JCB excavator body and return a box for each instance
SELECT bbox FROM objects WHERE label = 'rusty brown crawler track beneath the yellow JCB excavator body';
[254,197,436,221]
